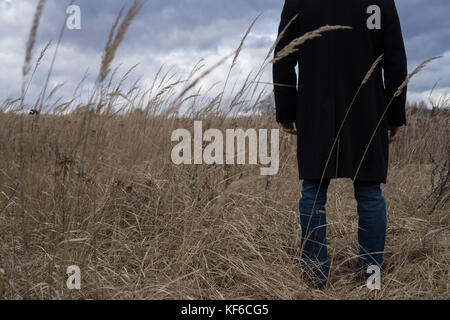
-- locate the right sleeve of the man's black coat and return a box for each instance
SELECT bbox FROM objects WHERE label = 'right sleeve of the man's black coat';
[382,0,408,127]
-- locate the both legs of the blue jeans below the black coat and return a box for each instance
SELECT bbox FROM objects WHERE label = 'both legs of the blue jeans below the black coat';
[299,180,386,283]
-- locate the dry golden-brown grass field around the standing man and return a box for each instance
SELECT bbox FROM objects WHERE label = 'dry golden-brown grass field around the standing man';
[0,2,450,299]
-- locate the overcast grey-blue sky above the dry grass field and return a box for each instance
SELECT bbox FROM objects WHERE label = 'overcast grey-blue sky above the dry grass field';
[0,0,450,109]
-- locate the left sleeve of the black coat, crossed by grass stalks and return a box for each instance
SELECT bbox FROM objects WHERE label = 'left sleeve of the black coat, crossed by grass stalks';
[273,0,299,123]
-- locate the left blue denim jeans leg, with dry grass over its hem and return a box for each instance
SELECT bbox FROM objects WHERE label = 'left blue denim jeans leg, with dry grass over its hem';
[299,180,330,283]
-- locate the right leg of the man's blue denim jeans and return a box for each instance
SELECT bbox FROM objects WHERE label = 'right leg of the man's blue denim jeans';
[354,182,387,273]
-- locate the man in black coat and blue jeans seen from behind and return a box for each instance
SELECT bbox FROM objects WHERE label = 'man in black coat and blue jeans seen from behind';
[273,0,407,287]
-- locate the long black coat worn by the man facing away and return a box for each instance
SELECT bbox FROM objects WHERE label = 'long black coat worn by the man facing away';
[273,0,407,183]
